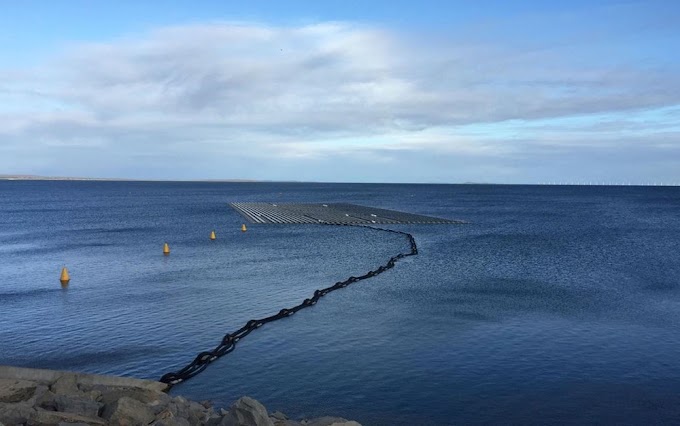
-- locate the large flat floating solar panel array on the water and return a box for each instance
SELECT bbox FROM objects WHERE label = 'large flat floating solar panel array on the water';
[230,203,465,225]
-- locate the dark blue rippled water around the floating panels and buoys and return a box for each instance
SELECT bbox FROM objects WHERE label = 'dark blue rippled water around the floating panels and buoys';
[0,182,680,425]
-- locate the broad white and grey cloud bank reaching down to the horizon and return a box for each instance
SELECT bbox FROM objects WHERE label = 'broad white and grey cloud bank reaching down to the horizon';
[0,22,680,182]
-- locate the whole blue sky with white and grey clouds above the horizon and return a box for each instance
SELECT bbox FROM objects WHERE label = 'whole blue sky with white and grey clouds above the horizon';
[0,0,680,184]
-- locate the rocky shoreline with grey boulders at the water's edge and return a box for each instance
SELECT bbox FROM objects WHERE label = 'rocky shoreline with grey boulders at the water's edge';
[0,366,361,426]
